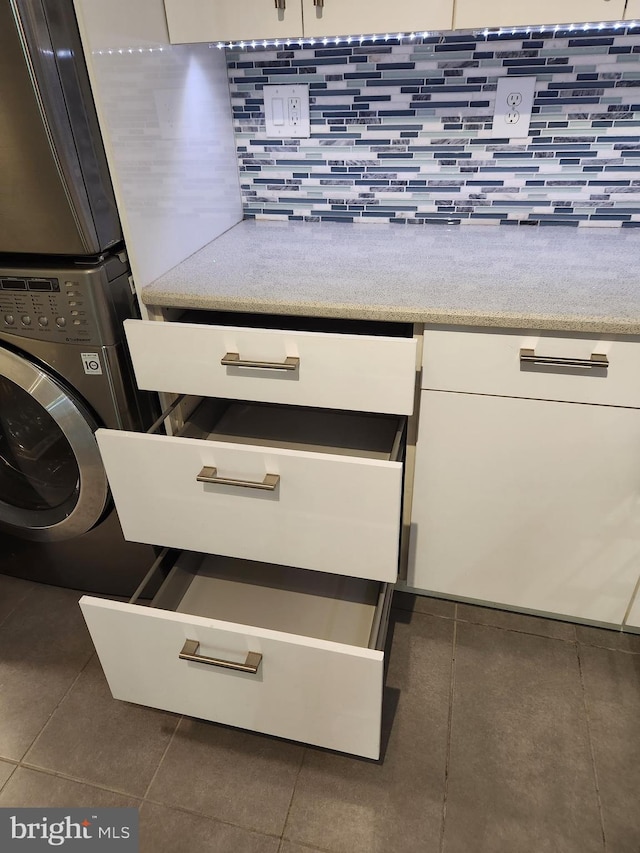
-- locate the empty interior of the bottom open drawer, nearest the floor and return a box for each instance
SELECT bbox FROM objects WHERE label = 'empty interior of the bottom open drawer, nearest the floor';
[138,551,390,648]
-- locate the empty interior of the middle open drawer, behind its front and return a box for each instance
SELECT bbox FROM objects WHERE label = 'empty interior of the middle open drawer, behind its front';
[179,399,405,461]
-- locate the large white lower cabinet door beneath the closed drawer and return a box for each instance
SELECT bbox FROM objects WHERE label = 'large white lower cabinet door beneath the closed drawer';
[407,392,640,625]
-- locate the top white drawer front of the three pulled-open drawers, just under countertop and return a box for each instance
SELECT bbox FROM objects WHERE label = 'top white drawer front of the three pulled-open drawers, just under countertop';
[124,320,416,415]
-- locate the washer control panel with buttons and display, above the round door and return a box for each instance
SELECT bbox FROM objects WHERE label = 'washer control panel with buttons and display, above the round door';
[0,275,94,341]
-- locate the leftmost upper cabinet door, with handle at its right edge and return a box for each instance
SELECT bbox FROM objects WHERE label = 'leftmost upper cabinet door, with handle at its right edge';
[164,0,302,44]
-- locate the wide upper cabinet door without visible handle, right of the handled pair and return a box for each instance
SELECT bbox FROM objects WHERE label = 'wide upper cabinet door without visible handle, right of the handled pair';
[454,0,624,30]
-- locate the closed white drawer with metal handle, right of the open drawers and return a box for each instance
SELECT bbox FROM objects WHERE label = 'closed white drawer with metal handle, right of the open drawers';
[421,328,640,407]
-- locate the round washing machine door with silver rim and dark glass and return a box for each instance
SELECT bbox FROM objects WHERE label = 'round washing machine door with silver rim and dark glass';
[0,348,109,542]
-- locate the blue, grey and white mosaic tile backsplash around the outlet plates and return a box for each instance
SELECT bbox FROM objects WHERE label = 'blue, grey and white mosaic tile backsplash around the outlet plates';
[227,26,640,228]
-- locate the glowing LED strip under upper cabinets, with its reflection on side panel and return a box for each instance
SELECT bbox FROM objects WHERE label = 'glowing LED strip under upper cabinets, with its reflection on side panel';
[93,21,640,56]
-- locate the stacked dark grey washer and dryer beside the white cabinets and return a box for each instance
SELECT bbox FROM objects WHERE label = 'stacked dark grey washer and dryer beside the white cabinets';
[0,0,156,595]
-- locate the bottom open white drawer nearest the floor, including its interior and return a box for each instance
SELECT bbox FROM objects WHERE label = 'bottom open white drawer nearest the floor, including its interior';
[80,551,392,758]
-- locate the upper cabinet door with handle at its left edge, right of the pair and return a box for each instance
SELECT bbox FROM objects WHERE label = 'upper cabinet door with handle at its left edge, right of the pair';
[302,0,456,37]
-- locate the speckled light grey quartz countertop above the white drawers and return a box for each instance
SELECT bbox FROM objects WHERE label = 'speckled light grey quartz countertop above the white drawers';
[142,220,640,334]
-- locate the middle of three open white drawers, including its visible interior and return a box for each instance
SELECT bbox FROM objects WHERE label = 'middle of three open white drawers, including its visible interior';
[96,400,405,582]
